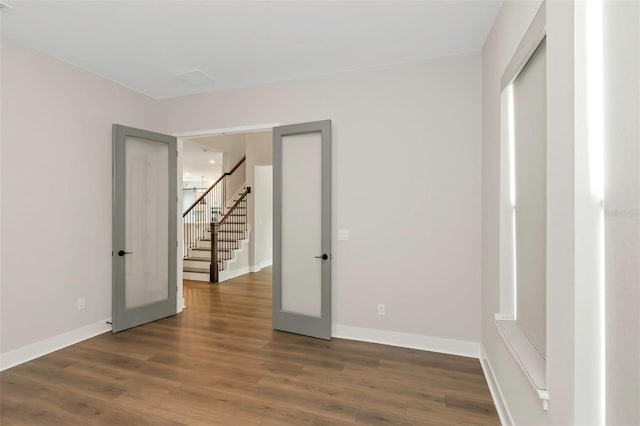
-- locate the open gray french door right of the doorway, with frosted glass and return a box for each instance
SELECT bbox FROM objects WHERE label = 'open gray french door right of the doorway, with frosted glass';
[272,120,331,340]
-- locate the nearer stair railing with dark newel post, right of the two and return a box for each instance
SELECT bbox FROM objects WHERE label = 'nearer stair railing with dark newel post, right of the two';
[209,186,251,283]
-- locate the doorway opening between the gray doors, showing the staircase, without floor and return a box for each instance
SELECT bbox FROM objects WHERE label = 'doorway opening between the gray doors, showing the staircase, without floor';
[175,124,277,312]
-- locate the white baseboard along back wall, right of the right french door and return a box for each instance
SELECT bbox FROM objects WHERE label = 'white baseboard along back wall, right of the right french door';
[331,324,480,358]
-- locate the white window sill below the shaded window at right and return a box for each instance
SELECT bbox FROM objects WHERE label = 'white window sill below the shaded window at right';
[495,314,549,411]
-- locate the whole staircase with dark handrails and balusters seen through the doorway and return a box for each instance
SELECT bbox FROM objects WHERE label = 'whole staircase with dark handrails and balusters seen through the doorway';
[183,159,251,282]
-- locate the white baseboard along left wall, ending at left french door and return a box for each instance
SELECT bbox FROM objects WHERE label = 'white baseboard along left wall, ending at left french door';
[0,318,111,371]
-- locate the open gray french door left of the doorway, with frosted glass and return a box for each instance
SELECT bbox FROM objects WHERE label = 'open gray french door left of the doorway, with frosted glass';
[112,124,177,333]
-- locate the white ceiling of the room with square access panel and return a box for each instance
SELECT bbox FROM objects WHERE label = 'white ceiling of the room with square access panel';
[0,0,501,99]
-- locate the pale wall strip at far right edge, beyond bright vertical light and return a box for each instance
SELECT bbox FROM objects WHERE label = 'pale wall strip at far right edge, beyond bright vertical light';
[604,1,640,425]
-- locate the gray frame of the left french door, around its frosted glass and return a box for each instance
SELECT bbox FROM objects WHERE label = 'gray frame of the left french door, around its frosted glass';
[111,124,178,333]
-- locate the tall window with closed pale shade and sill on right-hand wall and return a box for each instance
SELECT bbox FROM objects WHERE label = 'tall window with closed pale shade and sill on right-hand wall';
[496,4,549,409]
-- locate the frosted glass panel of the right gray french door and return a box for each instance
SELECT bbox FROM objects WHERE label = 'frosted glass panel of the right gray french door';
[281,132,322,317]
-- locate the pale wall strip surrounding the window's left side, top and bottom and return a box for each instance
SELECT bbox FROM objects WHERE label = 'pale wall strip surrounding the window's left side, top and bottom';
[482,1,552,424]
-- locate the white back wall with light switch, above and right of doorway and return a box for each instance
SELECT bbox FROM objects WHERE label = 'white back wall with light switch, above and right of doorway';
[161,53,481,342]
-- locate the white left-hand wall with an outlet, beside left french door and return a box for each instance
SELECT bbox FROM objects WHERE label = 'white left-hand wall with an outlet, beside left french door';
[0,39,164,359]
